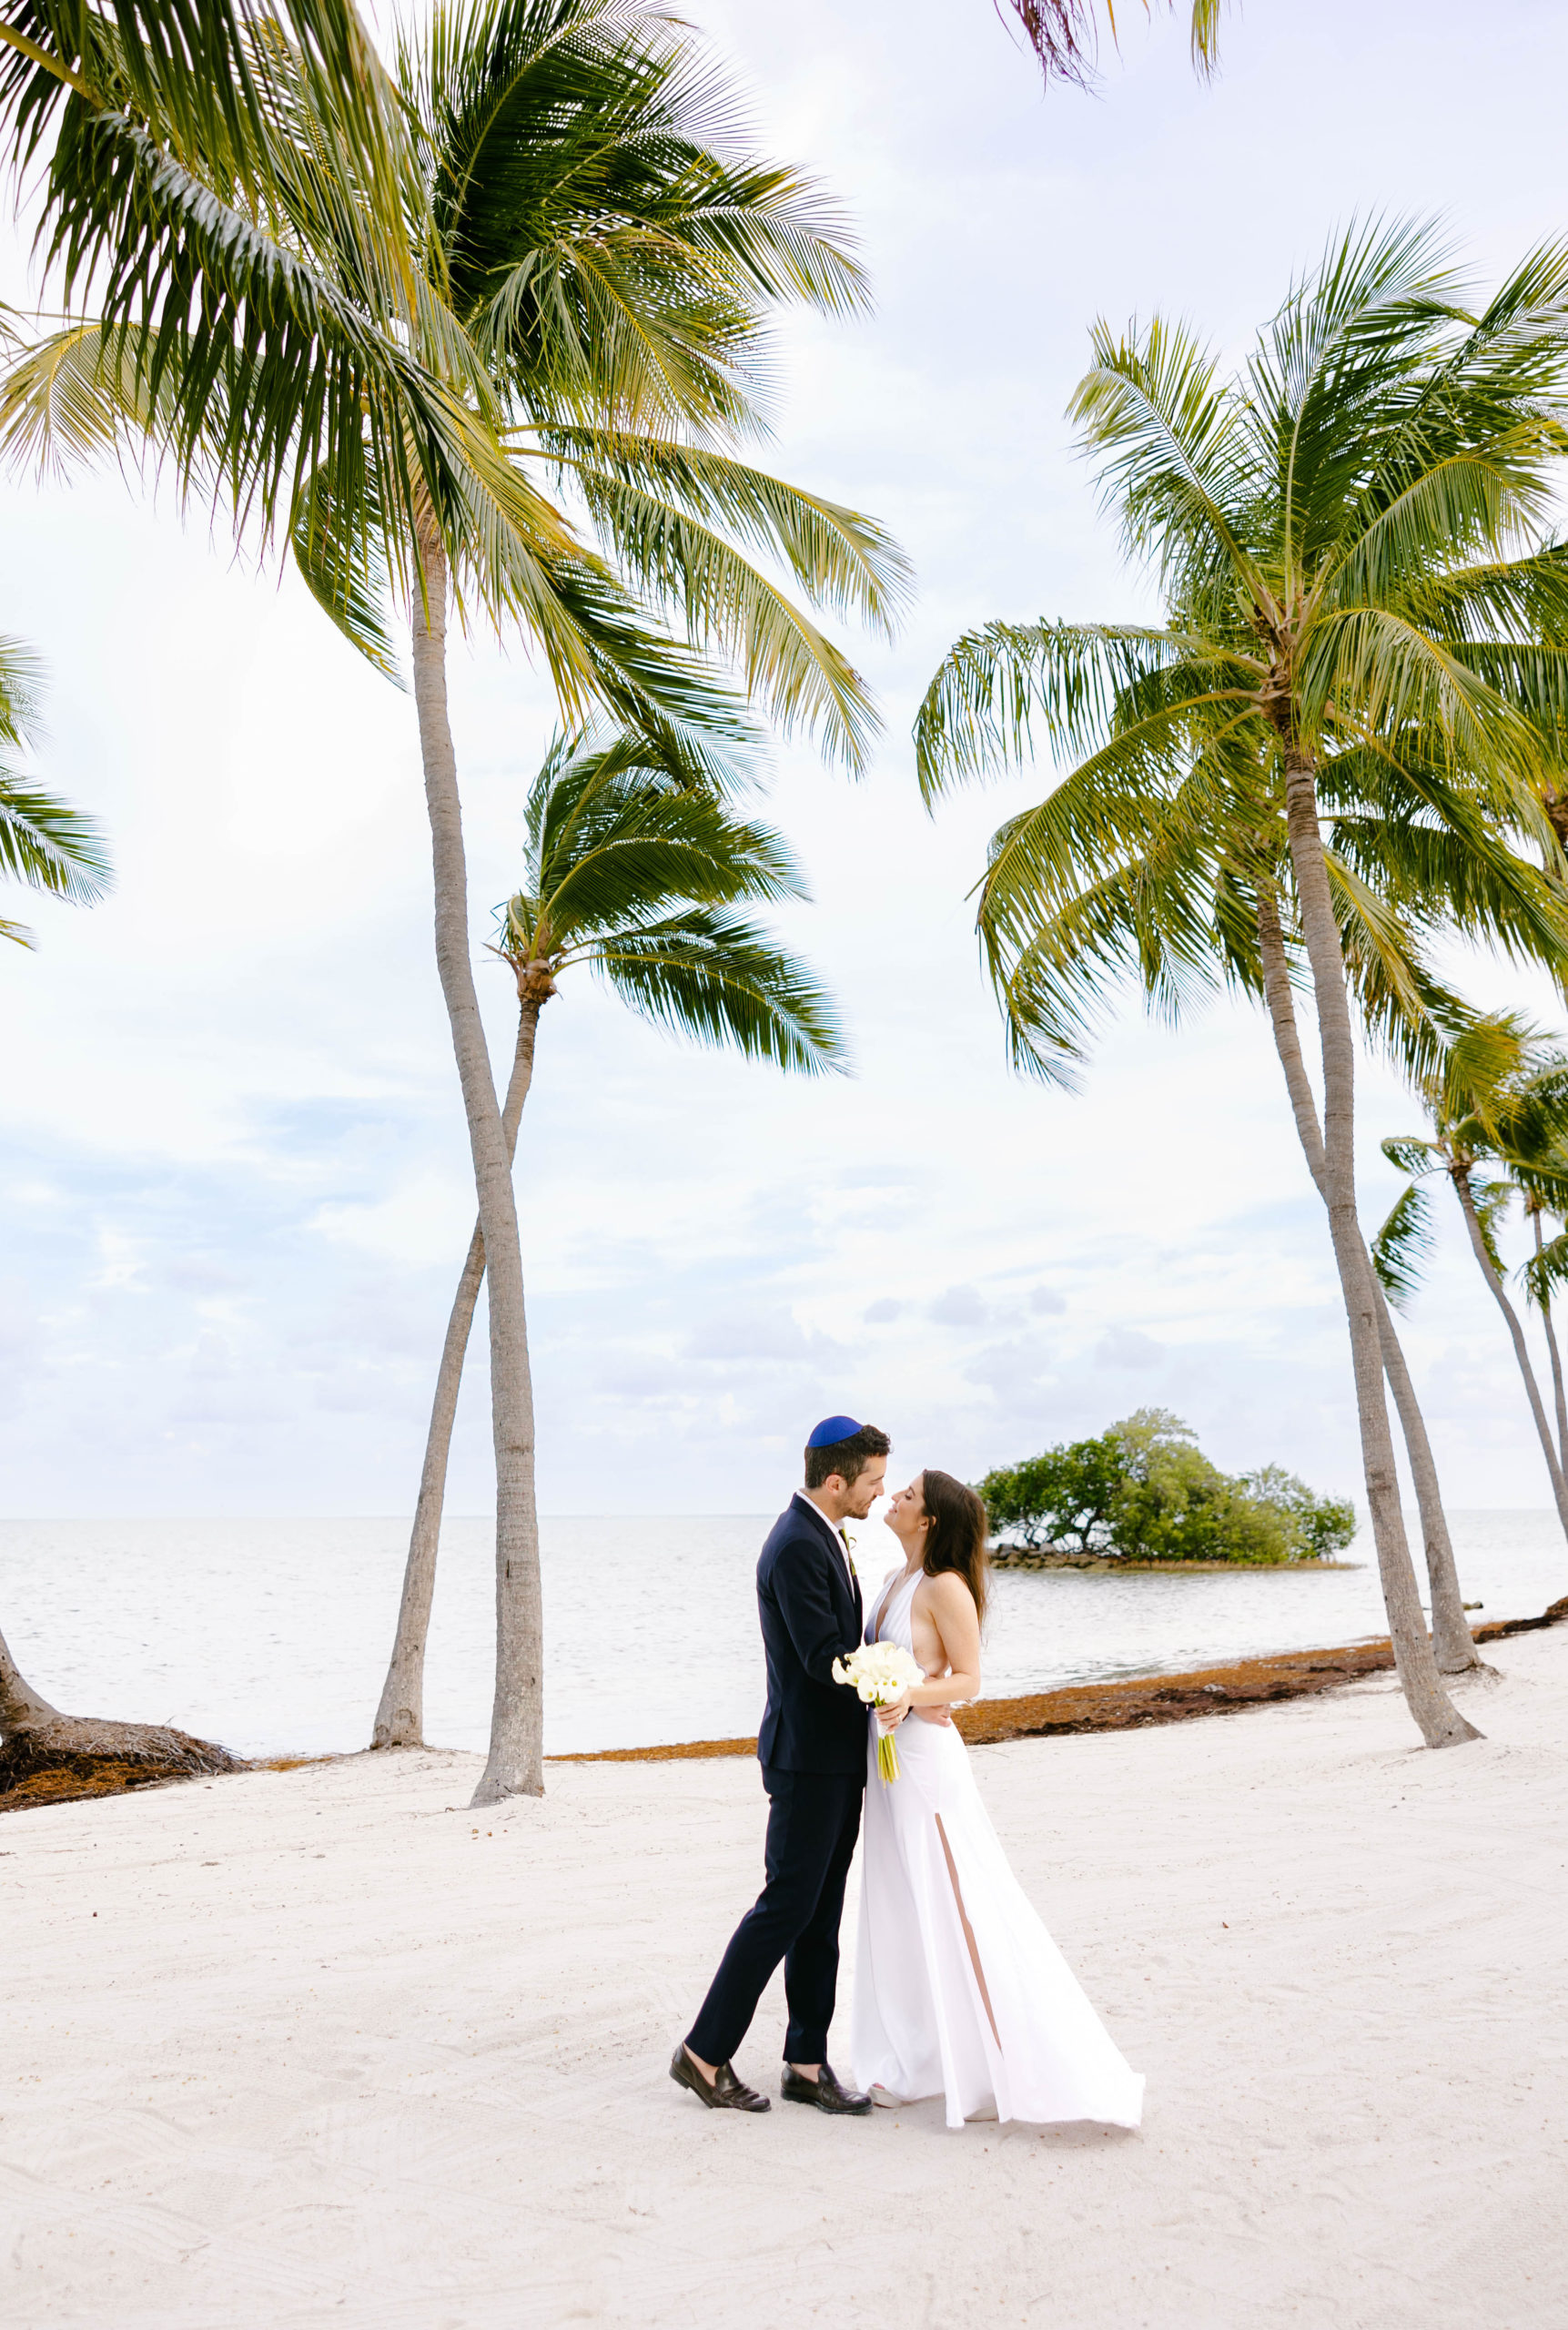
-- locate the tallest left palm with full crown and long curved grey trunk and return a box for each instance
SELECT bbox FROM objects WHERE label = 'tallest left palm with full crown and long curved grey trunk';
[0,0,906,1801]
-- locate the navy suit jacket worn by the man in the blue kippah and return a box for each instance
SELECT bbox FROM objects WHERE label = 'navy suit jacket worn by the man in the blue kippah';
[757,1494,866,1778]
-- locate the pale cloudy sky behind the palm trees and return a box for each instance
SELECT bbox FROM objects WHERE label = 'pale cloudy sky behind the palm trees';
[0,0,1568,1517]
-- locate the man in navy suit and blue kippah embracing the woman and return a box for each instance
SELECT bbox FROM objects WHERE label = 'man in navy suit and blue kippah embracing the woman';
[669,1416,893,2118]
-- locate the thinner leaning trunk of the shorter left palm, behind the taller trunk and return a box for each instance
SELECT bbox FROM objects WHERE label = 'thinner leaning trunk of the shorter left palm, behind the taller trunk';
[370,995,541,1748]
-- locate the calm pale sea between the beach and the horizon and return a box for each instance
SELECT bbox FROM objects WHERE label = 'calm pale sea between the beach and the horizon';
[0,1512,1568,1755]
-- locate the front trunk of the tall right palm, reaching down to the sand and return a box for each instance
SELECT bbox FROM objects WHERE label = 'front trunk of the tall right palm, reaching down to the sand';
[1286,744,1480,1748]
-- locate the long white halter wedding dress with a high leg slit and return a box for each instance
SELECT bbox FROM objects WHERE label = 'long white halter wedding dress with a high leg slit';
[853,1570,1144,2127]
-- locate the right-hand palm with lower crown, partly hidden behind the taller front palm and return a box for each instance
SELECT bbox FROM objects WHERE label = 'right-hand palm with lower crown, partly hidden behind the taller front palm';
[904,680,1528,1673]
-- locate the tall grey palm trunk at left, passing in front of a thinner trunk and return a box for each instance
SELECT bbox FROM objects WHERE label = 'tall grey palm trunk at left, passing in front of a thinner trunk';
[412,536,545,1803]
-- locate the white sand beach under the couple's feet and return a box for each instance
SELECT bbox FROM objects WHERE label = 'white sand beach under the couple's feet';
[0,1634,1568,2330]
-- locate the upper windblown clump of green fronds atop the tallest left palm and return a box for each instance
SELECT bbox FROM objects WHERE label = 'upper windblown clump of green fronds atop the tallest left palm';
[399,0,865,426]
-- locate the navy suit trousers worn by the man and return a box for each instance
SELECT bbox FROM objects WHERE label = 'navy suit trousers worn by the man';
[687,1771,866,2062]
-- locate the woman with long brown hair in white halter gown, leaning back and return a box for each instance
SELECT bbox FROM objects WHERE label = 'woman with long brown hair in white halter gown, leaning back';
[853,1473,1144,2127]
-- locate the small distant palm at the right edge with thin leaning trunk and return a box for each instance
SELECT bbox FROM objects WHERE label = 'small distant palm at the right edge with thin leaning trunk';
[1372,1011,1568,1535]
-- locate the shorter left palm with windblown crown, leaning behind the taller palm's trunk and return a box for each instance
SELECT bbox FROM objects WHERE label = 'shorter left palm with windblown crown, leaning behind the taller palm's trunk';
[373,732,844,1748]
